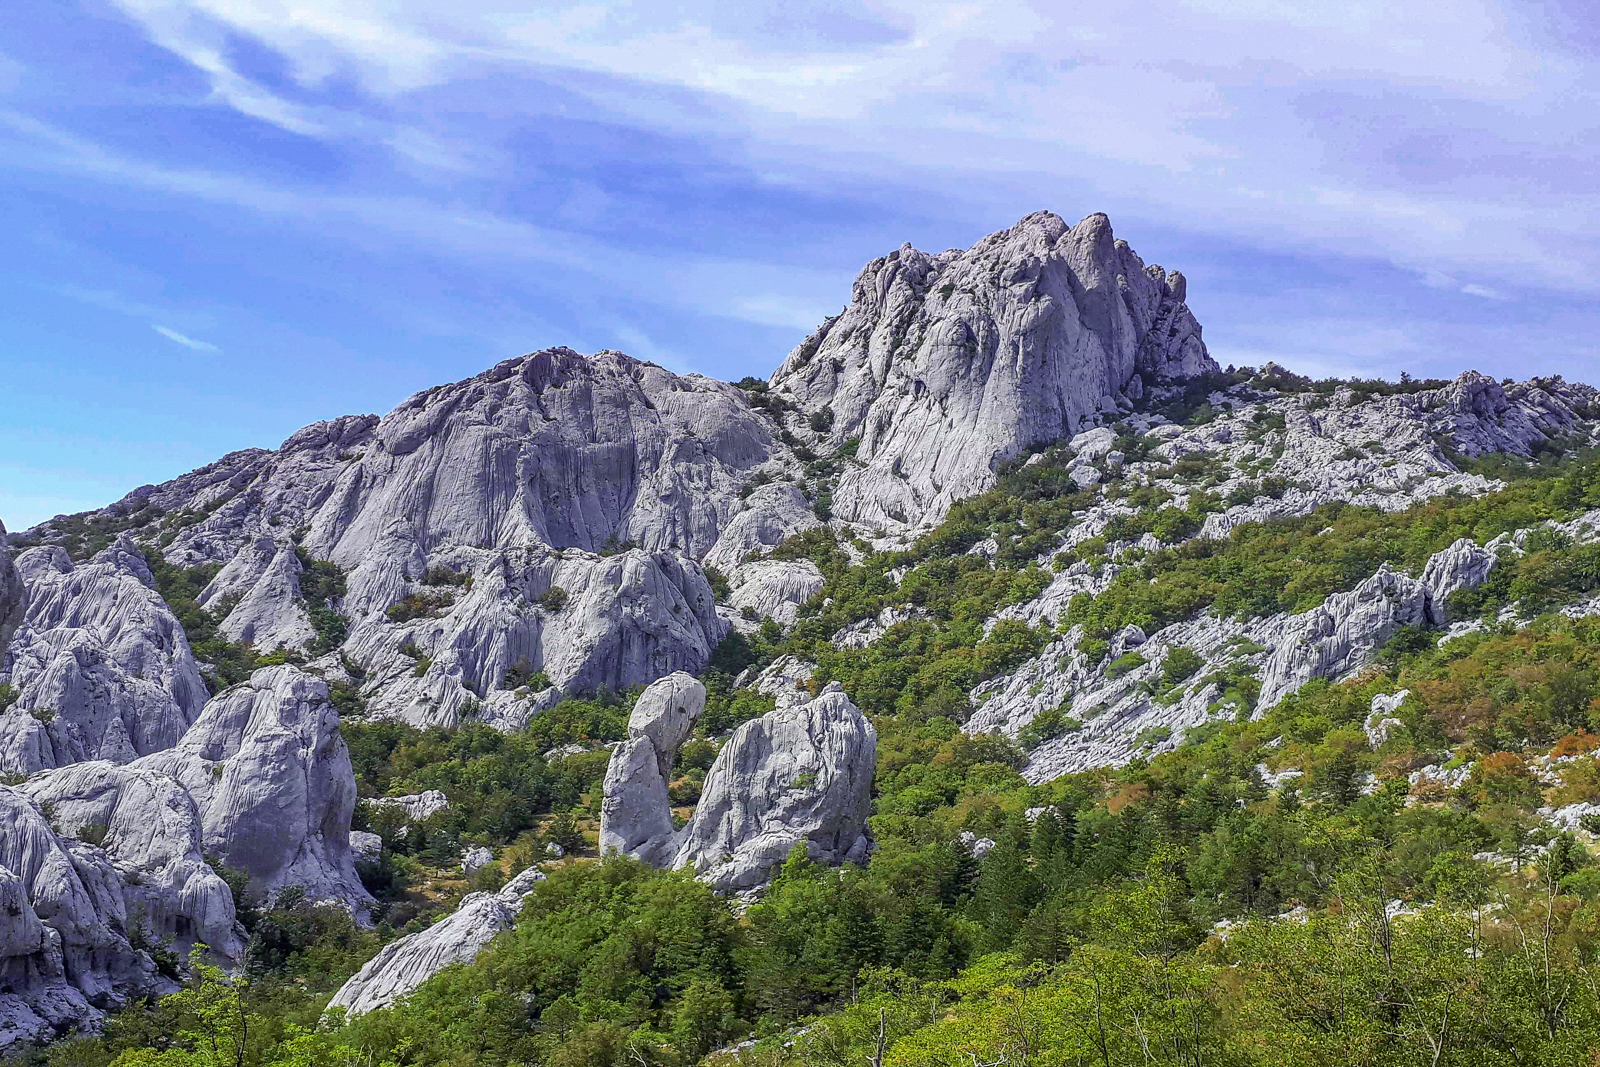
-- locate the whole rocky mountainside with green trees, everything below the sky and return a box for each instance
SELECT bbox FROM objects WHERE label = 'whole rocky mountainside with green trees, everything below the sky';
[0,213,1600,1067]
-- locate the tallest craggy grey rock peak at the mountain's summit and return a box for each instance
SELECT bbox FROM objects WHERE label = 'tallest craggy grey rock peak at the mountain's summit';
[771,211,1218,525]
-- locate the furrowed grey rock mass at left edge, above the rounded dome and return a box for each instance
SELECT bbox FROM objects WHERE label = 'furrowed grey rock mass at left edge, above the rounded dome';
[0,536,206,774]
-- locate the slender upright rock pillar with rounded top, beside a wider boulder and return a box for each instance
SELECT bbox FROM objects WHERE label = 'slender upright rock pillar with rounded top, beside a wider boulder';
[600,673,706,865]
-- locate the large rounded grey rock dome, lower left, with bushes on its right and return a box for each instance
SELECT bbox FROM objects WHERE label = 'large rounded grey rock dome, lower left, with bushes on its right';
[133,665,371,912]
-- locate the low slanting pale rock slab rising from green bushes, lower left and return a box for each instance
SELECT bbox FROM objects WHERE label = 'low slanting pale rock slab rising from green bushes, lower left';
[328,867,544,1017]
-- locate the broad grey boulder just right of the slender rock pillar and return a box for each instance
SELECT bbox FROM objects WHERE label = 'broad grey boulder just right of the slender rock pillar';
[674,683,878,893]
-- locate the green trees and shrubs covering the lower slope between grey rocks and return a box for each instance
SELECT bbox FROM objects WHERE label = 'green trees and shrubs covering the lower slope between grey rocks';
[34,431,1600,1067]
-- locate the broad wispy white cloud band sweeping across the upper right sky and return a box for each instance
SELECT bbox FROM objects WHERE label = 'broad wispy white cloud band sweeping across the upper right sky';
[93,0,1600,303]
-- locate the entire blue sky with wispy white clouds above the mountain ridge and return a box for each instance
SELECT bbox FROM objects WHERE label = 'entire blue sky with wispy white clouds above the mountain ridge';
[0,0,1600,530]
